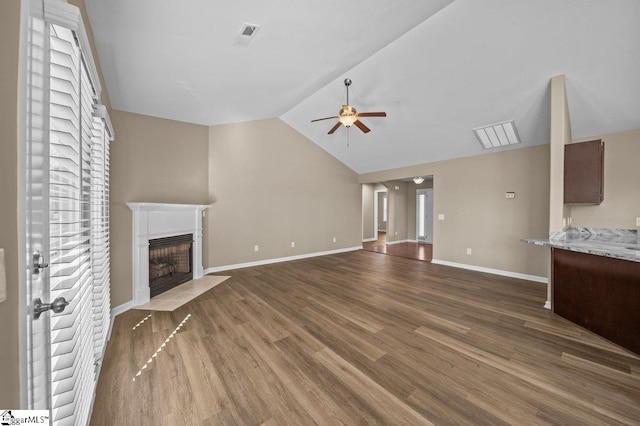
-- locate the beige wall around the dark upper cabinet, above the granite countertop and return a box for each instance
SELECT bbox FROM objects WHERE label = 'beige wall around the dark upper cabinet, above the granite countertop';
[571,129,640,229]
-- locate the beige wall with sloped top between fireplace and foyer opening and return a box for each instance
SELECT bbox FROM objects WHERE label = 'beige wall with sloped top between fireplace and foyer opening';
[205,119,362,268]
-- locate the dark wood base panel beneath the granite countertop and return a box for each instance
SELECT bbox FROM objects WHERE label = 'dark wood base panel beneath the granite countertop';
[552,248,640,354]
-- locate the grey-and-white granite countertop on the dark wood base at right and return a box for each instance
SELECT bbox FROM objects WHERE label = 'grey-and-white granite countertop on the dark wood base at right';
[522,228,640,262]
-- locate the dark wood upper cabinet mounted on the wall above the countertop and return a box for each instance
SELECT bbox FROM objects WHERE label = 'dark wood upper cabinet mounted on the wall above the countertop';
[564,140,604,204]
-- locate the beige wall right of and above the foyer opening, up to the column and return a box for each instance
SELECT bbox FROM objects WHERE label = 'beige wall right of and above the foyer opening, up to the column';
[359,145,549,277]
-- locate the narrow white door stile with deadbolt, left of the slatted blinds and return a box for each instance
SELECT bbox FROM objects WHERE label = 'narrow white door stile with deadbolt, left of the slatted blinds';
[22,13,51,410]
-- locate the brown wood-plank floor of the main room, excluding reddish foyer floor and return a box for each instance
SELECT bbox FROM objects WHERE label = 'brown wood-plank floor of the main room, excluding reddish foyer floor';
[91,250,640,425]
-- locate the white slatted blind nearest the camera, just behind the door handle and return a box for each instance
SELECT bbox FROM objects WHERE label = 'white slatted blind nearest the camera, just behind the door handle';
[49,25,95,425]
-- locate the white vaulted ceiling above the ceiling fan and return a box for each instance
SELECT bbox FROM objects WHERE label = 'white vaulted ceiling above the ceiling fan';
[86,0,640,173]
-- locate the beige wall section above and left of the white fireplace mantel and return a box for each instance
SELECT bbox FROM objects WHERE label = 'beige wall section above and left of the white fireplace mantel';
[111,110,208,307]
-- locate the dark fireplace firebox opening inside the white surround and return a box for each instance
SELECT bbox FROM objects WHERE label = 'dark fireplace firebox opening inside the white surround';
[149,234,193,297]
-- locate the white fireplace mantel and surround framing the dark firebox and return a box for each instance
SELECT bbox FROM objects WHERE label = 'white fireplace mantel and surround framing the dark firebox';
[127,202,209,306]
